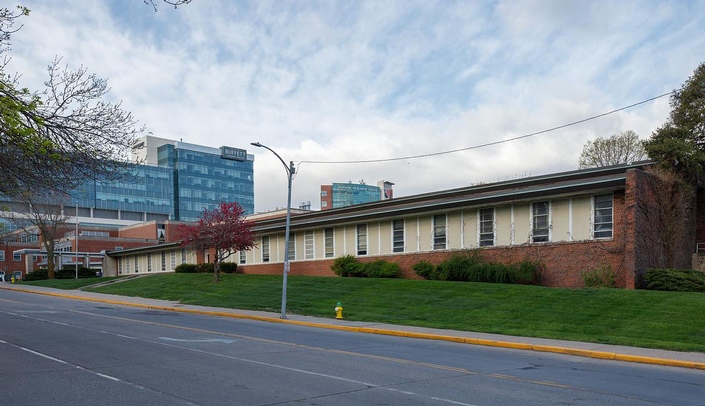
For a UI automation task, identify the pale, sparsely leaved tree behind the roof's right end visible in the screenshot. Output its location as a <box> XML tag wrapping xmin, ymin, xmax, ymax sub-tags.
<box><xmin>578</xmin><ymin>130</ymin><xmax>646</xmax><ymax>169</ymax></box>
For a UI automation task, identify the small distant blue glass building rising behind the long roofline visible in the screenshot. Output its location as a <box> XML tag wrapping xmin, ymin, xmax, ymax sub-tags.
<box><xmin>321</xmin><ymin>180</ymin><xmax>394</xmax><ymax>210</ymax></box>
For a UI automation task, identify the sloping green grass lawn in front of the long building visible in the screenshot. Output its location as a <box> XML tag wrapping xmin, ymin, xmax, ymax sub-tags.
<box><xmin>22</xmin><ymin>274</ymin><xmax>705</xmax><ymax>352</ymax></box>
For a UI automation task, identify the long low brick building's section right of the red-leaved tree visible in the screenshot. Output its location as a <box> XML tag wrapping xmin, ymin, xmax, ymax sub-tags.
<box><xmin>235</xmin><ymin>162</ymin><xmax>705</xmax><ymax>288</ymax></box>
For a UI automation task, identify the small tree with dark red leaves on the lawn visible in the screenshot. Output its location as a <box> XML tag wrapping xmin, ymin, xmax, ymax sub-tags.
<box><xmin>177</xmin><ymin>202</ymin><xmax>255</xmax><ymax>282</ymax></box>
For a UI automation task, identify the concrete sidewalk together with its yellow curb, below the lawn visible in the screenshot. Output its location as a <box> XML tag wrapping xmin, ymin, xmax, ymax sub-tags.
<box><xmin>0</xmin><ymin>282</ymin><xmax>705</xmax><ymax>370</ymax></box>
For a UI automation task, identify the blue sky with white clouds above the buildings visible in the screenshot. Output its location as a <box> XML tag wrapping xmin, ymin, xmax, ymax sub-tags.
<box><xmin>7</xmin><ymin>0</ymin><xmax>705</xmax><ymax>211</ymax></box>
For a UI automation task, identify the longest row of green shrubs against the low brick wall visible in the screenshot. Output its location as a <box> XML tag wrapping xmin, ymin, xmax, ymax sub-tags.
<box><xmin>413</xmin><ymin>251</ymin><xmax>543</xmax><ymax>285</ymax></box>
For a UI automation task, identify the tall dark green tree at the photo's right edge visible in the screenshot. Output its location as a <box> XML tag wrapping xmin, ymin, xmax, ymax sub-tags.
<box><xmin>645</xmin><ymin>63</ymin><xmax>705</xmax><ymax>185</ymax></box>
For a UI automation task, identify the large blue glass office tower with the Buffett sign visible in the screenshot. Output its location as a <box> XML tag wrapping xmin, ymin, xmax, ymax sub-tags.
<box><xmin>0</xmin><ymin>136</ymin><xmax>255</xmax><ymax>227</ymax></box>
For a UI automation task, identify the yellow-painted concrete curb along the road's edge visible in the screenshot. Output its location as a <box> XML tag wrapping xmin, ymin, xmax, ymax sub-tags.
<box><xmin>5</xmin><ymin>288</ymin><xmax>705</xmax><ymax>370</ymax></box>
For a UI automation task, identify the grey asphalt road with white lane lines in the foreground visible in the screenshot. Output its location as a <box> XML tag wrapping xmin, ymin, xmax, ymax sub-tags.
<box><xmin>0</xmin><ymin>290</ymin><xmax>705</xmax><ymax>406</ymax></box>
